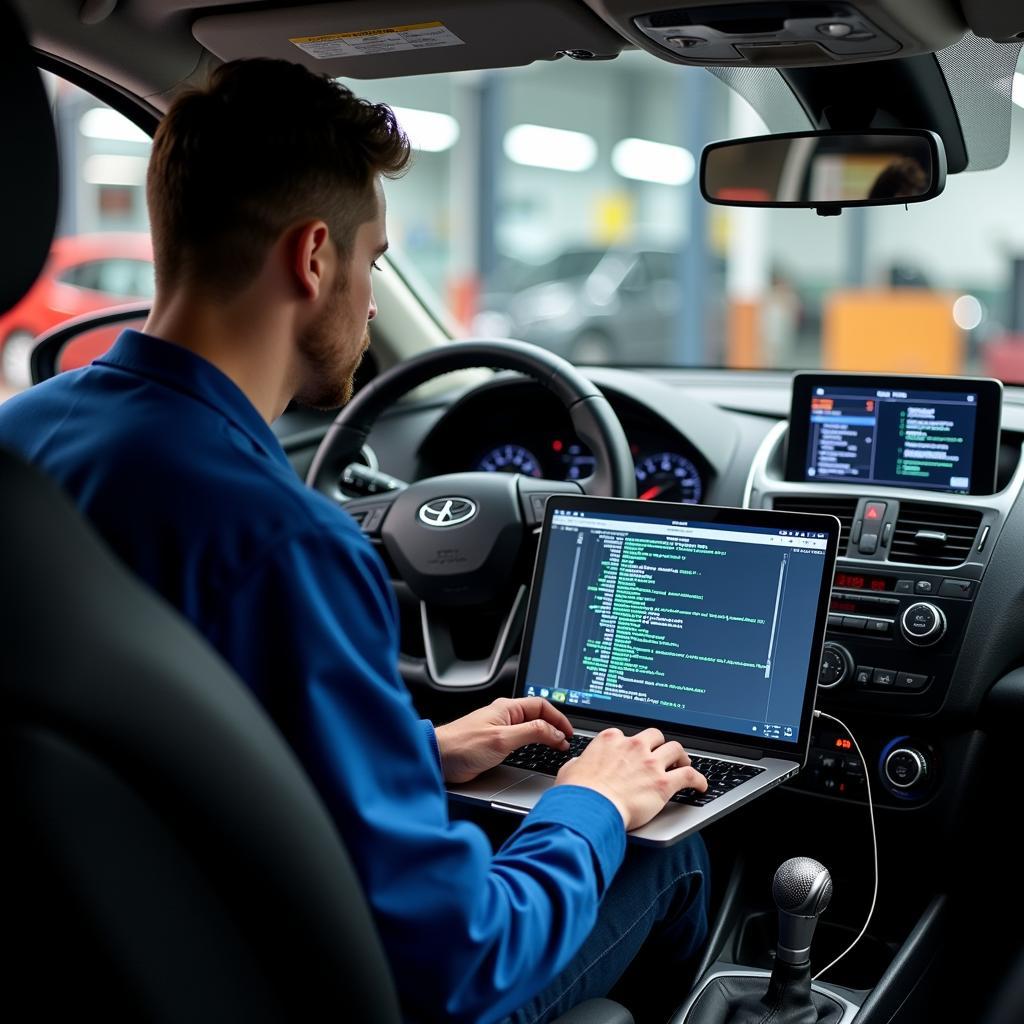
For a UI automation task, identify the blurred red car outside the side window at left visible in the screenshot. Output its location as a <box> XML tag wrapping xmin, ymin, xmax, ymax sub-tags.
<box><xmin>0</xmin><ymin>232</ymin><xmax>154</xmax><ymax>387</ymax></box>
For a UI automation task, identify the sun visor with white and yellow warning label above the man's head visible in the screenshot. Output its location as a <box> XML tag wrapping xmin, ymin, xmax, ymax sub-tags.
<box><xmin>193</xmin><ymin>0</ymin><xmax>625</xmax><ymax>78</ymax></box>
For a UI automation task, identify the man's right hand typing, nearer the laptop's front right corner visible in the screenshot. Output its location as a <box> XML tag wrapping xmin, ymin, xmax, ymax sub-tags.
<box><xmin>555</xmin><ymin>729</ymin><xmax>708</xmax><ymax>831</ymax></box>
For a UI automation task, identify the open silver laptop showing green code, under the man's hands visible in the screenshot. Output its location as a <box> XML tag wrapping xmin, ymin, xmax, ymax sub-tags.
<box><xmin>449</xmin><ymin>496</ymin><xmax>840</xmax><ymax>846</ymax></box>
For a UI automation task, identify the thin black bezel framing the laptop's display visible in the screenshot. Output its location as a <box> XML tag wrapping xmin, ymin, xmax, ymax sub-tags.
<box><xmin>514</xmin><ymin>495</ymin><xmax>840</xmax><ymax>760</ymax></box>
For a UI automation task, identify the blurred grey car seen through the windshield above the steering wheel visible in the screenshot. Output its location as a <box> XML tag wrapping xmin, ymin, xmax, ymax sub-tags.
<box><xmin>472</xmin><ymin>248</ymin><xmax>680</xmax><ymax>365</ymax></box>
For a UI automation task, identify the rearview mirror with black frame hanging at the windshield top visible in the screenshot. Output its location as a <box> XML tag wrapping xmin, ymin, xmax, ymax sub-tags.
<box><xmin>700</xmin><ymin>129</ymin><xmax>946</xmax><ymax>216</ymax></box>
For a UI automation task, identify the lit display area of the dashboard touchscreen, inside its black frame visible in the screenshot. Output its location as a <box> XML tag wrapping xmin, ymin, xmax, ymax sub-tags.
<box><xmin>807</xmin><ymin>387</ymin><xmax>978</xmax><ymax>495</ymax></box>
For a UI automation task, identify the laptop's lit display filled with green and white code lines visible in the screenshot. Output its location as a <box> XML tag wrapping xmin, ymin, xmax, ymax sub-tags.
<box><xmin>524</xmin><ymin>511</ymin><xmax>827</xmax><ymax>742</ymax></box>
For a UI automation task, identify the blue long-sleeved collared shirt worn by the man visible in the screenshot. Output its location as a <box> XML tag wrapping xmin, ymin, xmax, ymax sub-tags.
<box><xmin>0</xmin><ymin>331</ymin><xmax>625</xmax><ymax>1021</ymax></box>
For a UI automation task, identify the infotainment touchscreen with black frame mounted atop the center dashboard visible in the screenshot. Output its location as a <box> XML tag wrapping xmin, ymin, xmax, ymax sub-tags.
<box><xmin>786</xmin><ymin>374</ymin><xmax>1002</xmax><ymax>495</ymax></box>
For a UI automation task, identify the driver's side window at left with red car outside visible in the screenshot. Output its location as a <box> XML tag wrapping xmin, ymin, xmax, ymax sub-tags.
<box><xmin>0</xmin><ymin>73</ymin><xmax>154</xmax><ymax>400</ymax></box>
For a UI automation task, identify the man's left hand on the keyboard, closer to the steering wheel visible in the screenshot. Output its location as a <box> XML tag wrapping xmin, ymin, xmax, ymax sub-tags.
<box><xmin>434</xmin><ymin>697</ymin><xmax>572</xmax><ymax>782</ymax></box>
